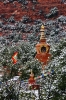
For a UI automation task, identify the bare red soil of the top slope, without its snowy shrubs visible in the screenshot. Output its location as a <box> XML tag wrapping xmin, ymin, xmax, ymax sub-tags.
<box><xmin>0</xmin><ymin>0</ymin><xmax>66</xmax><ymax>20</ymax></box>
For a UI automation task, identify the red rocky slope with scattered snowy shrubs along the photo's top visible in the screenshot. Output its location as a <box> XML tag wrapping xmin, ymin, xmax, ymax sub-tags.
<box><xmin>0</xmin><ymin>0</ymin><xmax>66</xmax><ymax>20</ymax></box>
